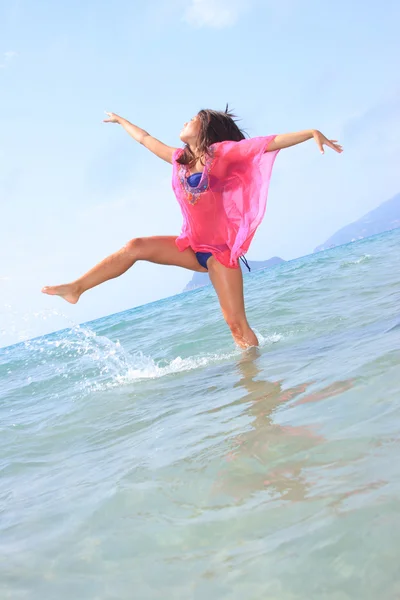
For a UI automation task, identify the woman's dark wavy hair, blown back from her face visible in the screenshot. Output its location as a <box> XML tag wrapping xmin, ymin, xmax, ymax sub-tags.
<box><xmin>177</xmin><ymin>105</ymin><xmax>245</xmax><ymax>166</ymax></box>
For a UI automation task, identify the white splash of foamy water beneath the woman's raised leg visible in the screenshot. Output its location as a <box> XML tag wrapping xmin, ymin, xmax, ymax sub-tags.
<box><xmin>3</xmin><ymin>311</ymin><xmax>283</xmax><ymax>396</ymax></box>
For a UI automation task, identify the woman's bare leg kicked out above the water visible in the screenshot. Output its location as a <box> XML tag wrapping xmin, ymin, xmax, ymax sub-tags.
<box><xmin>42</xmin><ymin>236</ymin><xmax>206</xmax><ymax>304</ymax></box>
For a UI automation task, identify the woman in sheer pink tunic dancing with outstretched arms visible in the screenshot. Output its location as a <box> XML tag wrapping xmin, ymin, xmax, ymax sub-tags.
<box><xmin>42</xmin><ymin>107</ymin><xmax>342</xmax><ymax>348</ymax></box>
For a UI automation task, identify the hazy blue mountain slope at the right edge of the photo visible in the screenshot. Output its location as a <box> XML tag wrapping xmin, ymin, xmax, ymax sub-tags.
<box><xmin>314</xmin><ymin>194</ymin><xmax>400</xmax><ymax>252</ymax></box>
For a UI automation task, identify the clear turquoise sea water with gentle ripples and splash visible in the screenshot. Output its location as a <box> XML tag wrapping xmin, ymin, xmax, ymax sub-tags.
<box><xmin>0</xmin><ymin>230</ymin><xmax>400</xmax><ymax>600</ymax></box>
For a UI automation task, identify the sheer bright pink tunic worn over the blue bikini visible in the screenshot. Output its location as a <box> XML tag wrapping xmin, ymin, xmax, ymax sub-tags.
<box><xmin>172</xmin><ymin>135</ymin><xmax>278</xmax><ymax>268</ymax></box>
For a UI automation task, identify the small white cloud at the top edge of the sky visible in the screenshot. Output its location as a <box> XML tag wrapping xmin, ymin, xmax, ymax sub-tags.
<box><xmin>184</xmin><ymin>0</ymin><xmax>250</xmax><ymax>29</ymax></box>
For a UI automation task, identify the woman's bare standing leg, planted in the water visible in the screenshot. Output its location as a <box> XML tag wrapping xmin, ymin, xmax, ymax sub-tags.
<box><xmin>207</xmin><ymin>256</ymin><xmax>258</xmax><ymax>348</ymax></box>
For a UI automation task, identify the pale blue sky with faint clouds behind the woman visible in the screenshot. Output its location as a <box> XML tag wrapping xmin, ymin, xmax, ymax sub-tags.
<box><xmin>0</xmin><ymin>0</ymin><xmax>400</xmax><ymax>345</ymax></box>
